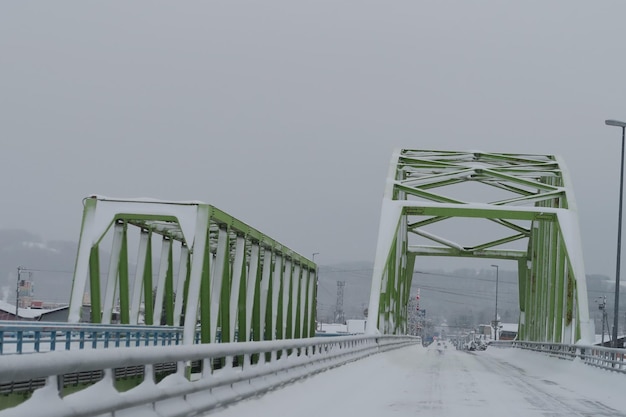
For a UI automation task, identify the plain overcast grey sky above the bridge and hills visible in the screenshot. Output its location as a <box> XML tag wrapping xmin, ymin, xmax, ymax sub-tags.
<box><xmin>0</xmin><ymin>0</ymin><xmax>626</xmax><ymax>276</ymax></box>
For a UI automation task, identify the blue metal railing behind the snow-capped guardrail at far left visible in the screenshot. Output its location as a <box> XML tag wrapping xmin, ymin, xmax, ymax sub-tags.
<box><xmin>0</xmin><ymin>321</ymin><xmax>188</xmax><ymax>355</ymax></box>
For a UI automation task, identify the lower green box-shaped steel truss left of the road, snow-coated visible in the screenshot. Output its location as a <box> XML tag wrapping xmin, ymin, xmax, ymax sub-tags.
<box><xmin>69</xmin><ymin>196</ymin><xmax>317</xmax><ymax>344</ymax></box>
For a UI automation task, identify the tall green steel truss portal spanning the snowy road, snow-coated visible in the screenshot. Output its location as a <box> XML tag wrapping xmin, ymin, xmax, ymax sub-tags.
<box><xmin>368</xmin><ymin>149</ymin><xmax>593</xmax><ymax>343</ymax></box>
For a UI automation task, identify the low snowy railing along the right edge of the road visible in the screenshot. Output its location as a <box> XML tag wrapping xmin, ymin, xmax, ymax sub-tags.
<box><xmin>492</xmin><ymin>341</ymin><xmax>626</xmax><ymax>373</ymax></box>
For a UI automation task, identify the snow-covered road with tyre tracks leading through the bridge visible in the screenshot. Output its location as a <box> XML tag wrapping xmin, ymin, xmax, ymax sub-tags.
<box><xmin>210</xmin><ymin>346</ymin><xmax>626</xmax><ymax>417</ymax></box>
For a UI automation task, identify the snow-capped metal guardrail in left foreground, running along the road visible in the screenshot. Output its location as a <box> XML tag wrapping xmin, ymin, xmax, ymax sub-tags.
<box><xmin>0</xmin><ymin>335</ymin><xmax>419</xmax><ymax>417</ymax></box>
